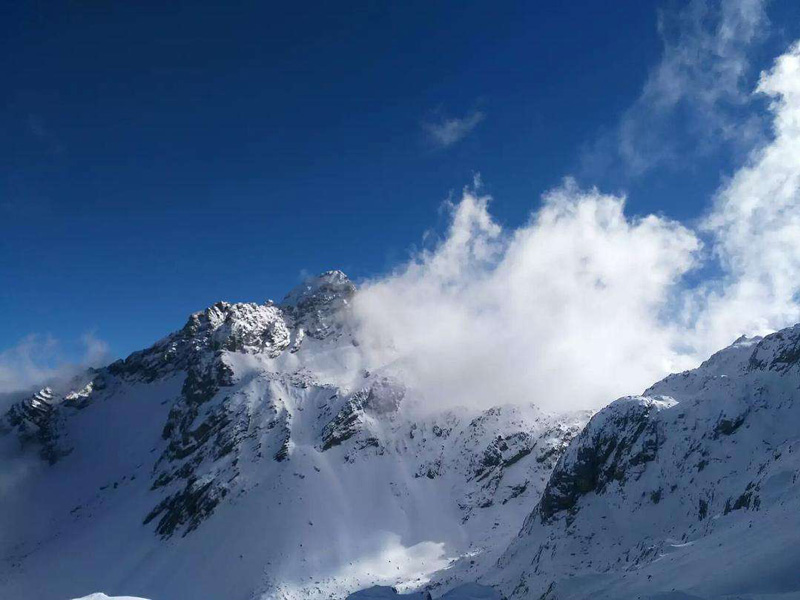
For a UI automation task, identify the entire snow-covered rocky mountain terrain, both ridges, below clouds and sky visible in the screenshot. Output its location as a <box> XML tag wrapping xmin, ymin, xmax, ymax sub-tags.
<box><xmin>0</xmin><ymin>271</ymin><xmax>800</xmax><ymax>600</ymax></box>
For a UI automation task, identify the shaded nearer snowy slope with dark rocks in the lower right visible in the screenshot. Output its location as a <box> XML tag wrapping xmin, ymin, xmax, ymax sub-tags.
<box><xmin>485</xmin><ymin>325</ymin><xmax>800</xmax><ymax>600</ymax></box>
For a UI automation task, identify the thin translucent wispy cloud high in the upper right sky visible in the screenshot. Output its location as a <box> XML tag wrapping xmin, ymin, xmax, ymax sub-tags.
<box><xmin>583</xmin><ymin>0</ymin><xmax>769</xmax><ymax>176</ymax></box>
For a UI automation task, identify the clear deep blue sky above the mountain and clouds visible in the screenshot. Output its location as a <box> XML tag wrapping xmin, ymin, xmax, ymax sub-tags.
<box><xmin>0</xmin><ymin>0</ymin><xmax>798</xmax><ymax>356</ymax></box>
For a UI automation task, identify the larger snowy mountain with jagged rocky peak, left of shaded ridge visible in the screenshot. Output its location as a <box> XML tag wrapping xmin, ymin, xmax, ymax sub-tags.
<box><xmin>0</xmin><ymin>271</ymin><xmax>589</xmax><ymax>600</ymax></box>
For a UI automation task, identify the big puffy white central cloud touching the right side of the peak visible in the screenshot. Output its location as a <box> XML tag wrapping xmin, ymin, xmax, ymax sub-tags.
<box><xmin>354</xmin><ymin>182</ymin><xmax>699</xmax><ymax>408</ymax></box>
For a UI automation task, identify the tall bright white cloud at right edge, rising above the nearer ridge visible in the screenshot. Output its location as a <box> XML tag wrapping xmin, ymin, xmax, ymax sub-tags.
<box><xmin>698</xmin><ymin>43</ymin><xmax>800</xmax><ymax>352</ymax></box>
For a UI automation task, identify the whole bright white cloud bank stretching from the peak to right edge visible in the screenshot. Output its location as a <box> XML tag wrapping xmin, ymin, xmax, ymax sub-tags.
<box><xmin>354</xmin><ymin>45</ymin><xmax>800</xmax><ymax>409</ymax></box>
